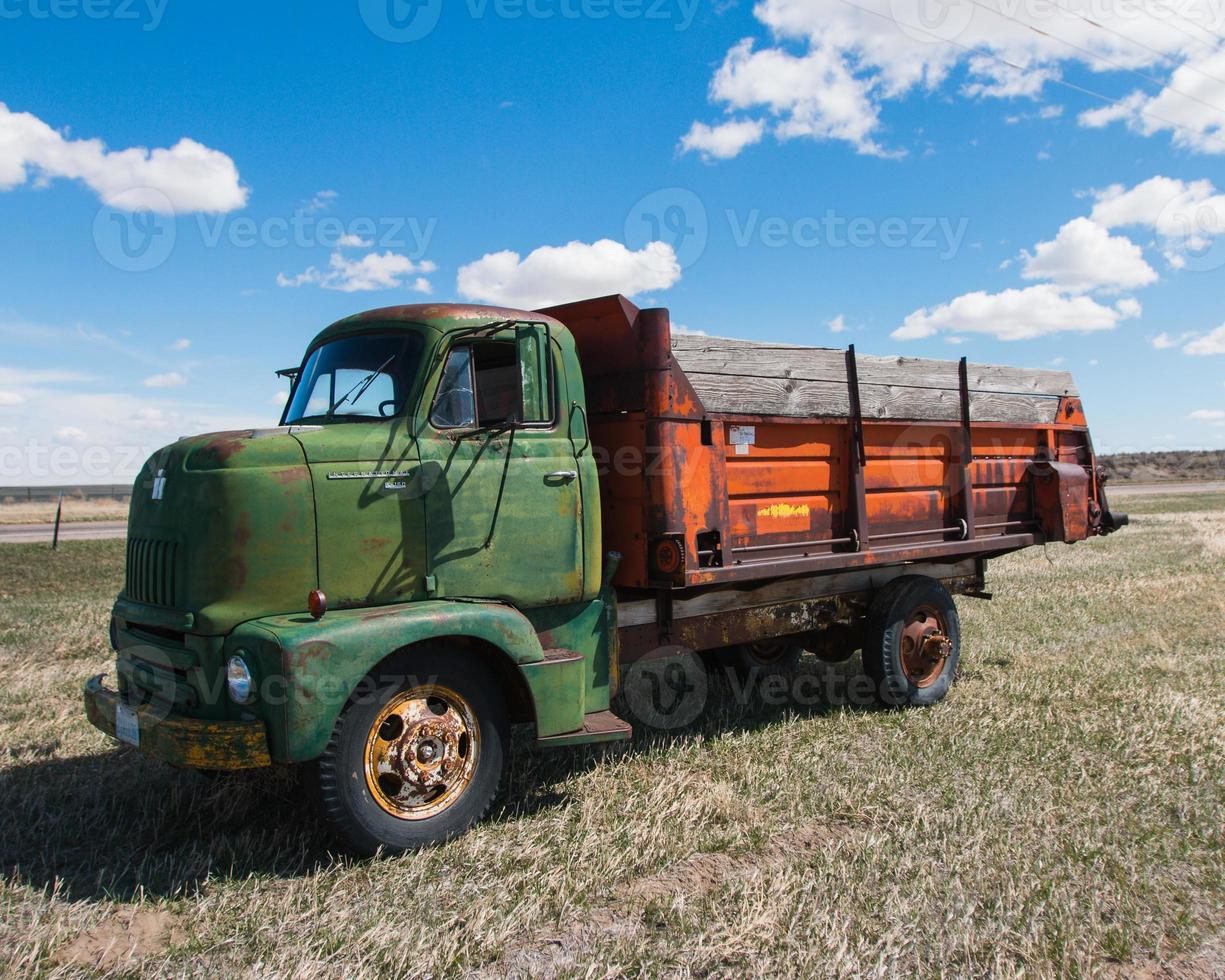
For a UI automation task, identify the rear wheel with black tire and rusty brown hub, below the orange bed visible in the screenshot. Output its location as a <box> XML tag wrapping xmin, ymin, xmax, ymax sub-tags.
<box><xmin>864</xmin><ymin>576</ymin><xmax>962</xmax><ymax>707</ymax></box>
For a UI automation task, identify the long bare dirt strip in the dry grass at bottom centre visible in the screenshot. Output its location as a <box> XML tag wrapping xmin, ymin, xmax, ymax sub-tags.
<box><xmin>472</xmin><ymin>823</ymin><xmax>853</xmax><ymax>980</ymax></box>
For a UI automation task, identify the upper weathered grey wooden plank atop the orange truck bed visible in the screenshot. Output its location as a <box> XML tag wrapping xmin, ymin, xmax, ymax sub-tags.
<box><xmin>673</xmin><ymin>334</ymin><xmax>1077</xmax><ymax>396</ymax></box>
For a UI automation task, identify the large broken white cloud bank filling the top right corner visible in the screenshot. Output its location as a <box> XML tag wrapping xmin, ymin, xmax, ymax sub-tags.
<box><xmin>681</xmin><ymin>0</ymin><xmax>1225</xmax><ymax>157</ymax></box>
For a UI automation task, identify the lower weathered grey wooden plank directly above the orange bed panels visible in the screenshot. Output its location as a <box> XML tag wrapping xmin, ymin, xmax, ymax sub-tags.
<box><xmin>687</xmin><ymin>372</ymin><xmax>1058</xmax><ymax>424</ymax></box>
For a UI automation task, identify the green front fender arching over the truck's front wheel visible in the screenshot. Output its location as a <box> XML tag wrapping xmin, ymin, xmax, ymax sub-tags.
<box><xmin>235</xmin><ymin>599</ymin><xmax>551</xmax><ymax>762</ymax></box>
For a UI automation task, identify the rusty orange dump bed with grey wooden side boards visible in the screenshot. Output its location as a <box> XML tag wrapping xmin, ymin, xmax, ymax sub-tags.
<box><xmin>545</xmin><ymin>296</ymin><xmax>1114</xmax><ymax>588</ymax></box>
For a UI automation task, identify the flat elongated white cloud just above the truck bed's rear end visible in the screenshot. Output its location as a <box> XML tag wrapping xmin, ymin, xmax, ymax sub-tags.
<box><xmin>891</xmin><ymin>283</ymin><xmax>1140</xmax><ymax>341</ymax></box>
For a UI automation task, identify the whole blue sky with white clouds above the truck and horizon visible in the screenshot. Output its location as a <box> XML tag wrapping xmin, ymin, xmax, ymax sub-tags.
<box><xmin>0</xmin><ymin>0</ymin><xmax>1225</xmax><ymax>486</ymax></box>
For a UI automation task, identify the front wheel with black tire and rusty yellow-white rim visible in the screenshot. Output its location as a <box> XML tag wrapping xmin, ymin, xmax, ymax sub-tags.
<box><xmin>314</xmin><ymin>647</ymin><xmax>508</xmax><ymax>856</ymax></box>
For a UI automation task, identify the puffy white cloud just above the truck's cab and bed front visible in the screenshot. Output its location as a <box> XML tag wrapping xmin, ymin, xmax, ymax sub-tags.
<box><xmin>457</xmin><ymin>239</ymin><xmax>681</xmax><ymax>309</ymax></box>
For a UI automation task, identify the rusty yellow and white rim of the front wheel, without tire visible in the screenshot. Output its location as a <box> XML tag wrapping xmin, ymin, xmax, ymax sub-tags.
<box><xmin>365</xmin><ymin>686</ymin><xmax>480</xmax><ymax>820</ymax></box>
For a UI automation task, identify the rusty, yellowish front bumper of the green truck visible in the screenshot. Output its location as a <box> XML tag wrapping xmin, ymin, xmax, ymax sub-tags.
<box><xmin>85</xmin><ymin>674</ymin><xmax>272</xmax><ymax>769</ymax></box>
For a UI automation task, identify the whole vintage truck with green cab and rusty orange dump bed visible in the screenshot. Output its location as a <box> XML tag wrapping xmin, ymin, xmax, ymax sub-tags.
<box><xmin>85</xmin><ymin>296</ymin><xmax>1126</xmax><ymax>854</ymax></box>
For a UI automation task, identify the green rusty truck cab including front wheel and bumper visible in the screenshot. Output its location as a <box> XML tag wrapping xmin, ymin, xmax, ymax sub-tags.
<box><xmin>86</xmin><ymin>305</ymin><xmax>628</xmax><ymax>853</ymax></box>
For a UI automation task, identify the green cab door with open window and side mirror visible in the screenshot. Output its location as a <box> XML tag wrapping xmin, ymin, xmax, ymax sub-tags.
<box><xmin>419</xmin><ymin>325</ymin><xmax>584</xmax><ymax>609</ymax></box>
